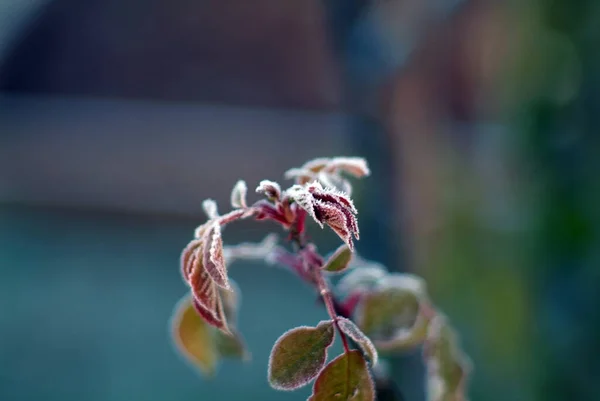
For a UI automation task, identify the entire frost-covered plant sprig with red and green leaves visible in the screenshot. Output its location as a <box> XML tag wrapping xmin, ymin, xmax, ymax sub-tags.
<box><xmin>172</xmin><ymin>157</ymin><xmax>470</xmax><ymax>401</ymax></box>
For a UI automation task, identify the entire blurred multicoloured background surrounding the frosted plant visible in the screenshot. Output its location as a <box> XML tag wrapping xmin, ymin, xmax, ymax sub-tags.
<box><xmin>0</xmin><ymin>0</ymin><xmax>600</xmax><ymax>401</ymax></box>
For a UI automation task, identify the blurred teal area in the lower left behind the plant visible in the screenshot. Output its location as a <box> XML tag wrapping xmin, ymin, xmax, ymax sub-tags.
<box><xmin>0</xmin><ymin>206</ymin><xmax>339</xmax><ymax>401</ymax></box>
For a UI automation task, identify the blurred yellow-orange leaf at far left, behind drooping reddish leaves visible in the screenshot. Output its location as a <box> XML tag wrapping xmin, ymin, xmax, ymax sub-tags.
<box><xmin>171</xmin><ymin>295</ymin><xmax>219</xmax><ymax>376</ymax></box>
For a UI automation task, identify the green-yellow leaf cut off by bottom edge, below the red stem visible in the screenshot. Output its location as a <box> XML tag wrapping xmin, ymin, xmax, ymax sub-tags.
<box><xmin>308</xmin><ymin>350</ymin><xmax>375</xmax><ymax>401</ymax></box>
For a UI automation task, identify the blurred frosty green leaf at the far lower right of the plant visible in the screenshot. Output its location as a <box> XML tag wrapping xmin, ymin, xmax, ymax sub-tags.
<box><xmin>423</xmin><ymin>314</ymin><xmax>471</xmax><ymax>401</ymax></box>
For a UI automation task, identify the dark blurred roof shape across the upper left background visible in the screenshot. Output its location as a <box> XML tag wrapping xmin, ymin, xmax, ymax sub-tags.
<box><xmin>0</xmin><ymin>0</ymin><xmax>339</xmax><ymax>109</ymax></box>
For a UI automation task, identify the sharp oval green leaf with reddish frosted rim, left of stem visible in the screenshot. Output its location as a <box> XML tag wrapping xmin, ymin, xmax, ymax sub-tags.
<box><xmin>268</xmin><ymin>320</ymin><xmax>335</xmax><ymax>390</ymax></box>
